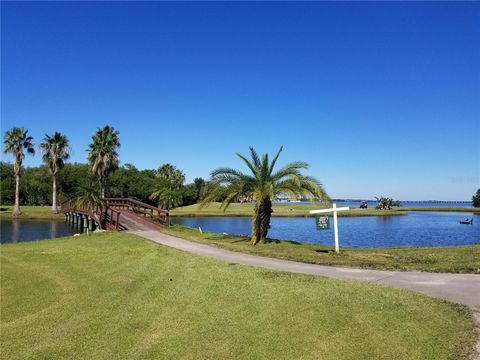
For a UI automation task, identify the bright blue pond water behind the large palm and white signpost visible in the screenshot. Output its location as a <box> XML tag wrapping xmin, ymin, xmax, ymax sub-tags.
<box><xmin>171</xmin><ymin>212</ymin><xmax>480</xmax><ymax>247</ymax></box>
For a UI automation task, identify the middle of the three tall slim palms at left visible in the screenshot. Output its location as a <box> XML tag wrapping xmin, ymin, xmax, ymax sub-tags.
<box><xmin>40</xmin><ymin>132</ymin><xmax>70</xmax><ymax>214</ymax></box>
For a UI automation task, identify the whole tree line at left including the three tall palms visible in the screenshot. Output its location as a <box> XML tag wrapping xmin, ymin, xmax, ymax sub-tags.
<box><xmin>0</xmin><ymin>125</ymin><xmax>234</xmax><ymax>216</ymax></box>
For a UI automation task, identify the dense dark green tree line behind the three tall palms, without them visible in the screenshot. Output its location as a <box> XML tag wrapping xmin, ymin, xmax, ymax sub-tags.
<box><xmin>0</xmin><ymin>161</ymin><xmax>217</xmax><ymax>209</ymax></box>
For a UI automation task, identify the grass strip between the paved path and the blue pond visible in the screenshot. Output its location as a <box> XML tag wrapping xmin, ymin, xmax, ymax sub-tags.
<box><xmin>164</xmin><ymin>225</ymin><xmax>480</xmax><ymax>274</ymax></box>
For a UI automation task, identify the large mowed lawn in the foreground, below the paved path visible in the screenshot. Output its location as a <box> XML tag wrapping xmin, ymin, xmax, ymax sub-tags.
<box><xmin>0</xmin><ymin>233</ymin><xmax>475</xmax><ymax>360</ymax></box>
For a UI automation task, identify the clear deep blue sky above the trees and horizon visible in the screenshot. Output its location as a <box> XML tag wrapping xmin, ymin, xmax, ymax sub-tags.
<box><xmin>1</xmin><ymin>2</ymin><xmax>480</xmax><ymax>200</ymax></box>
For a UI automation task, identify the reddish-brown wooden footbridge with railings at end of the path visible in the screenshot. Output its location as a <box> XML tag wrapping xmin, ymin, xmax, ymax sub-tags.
<box><xmin>62</xmin><ymin>198</ymin><xmax>170</xmax><ymax>231</ymax></box>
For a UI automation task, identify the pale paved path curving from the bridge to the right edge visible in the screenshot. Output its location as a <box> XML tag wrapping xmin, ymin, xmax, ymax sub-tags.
<box><xmin>129</xmin><ymin>230</ymin><xmax>480</xmax><ymax>360</ymax></box>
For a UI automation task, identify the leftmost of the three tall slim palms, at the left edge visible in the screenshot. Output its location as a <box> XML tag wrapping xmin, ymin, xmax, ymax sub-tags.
<box><xmin>3</xmin><ymin>127</ymin><xmax>35</xmax><ymax>216</ymax></box>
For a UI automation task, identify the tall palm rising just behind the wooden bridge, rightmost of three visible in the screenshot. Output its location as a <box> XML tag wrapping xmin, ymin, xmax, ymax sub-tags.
<box><xmin>87</xmin><ymin>125</ymin><xmax>120</xmax><ymax>198</ymax></box>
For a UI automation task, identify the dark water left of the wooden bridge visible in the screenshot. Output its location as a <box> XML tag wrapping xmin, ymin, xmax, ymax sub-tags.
<box><xmin>0</xmin><ymin>219</ymin><xmax>78</xmax><ymax>244</ymax></box>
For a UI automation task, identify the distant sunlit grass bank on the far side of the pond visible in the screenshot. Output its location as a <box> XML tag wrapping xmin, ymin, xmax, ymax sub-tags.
<box><xmin>170</xmin><ymin>203</ymin><xmax>406</xmax><ymax>217</ymax></box>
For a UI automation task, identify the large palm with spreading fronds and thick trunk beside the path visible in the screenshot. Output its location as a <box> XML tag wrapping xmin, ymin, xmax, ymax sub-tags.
<box><xmin>202</xmin><ymin>146</ymin><xmax>330</xmax><ymax>245</ymax></box>
